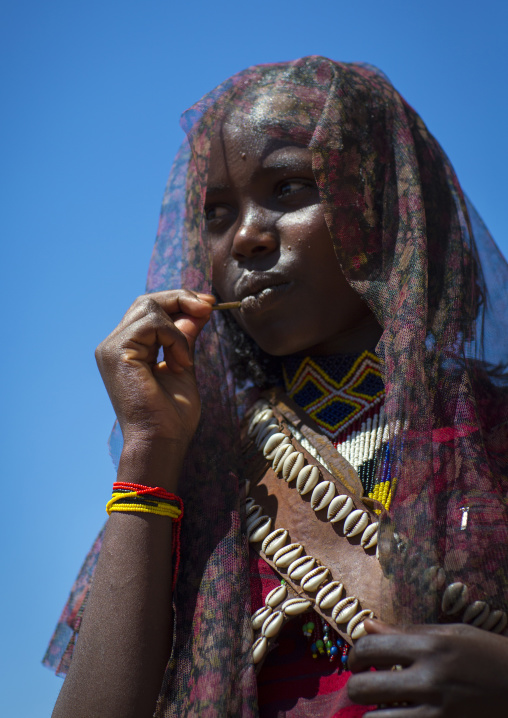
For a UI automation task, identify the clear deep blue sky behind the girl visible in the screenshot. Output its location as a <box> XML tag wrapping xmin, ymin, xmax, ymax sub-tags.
<box><xmin>0</xmin><ymin>0</ymin><xmax>508</xmax><ymax>718</ymax></box>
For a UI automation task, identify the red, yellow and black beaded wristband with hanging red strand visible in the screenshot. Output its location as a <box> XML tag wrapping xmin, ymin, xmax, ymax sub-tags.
<box><xmin>106</xmin><ymin>481</ymin><xmax>183</xmax><ymax>590</ymax></box>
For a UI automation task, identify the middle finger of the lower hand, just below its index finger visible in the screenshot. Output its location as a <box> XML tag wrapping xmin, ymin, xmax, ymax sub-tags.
<box><xmin>347</xmin><ymin>668</ymin><xmax>428</xmax><ymax>705</ymax></box>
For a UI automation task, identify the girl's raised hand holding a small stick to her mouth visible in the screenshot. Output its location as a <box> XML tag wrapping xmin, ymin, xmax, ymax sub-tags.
<box><xmin>96</xmin><ymin>289</ymin><xmax>215</xmax><ymax>462</ymax></box>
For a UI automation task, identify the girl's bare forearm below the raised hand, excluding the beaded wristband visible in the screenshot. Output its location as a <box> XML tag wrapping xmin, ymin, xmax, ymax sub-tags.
<box><xmin>53</xmin><ymin>446</ymin><xmax>184</xmax><ymax>718</ymax></box>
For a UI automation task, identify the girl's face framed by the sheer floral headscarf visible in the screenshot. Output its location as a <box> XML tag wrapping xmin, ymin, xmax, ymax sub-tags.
<box><xmin>205</xmin><ymin>123</ymin><xmax>381</xmax><ymax>356</ymax></box>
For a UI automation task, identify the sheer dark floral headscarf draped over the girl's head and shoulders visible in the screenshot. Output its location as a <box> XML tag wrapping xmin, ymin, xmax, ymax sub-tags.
<box><xmin>43</xmin><ymin>57</ymin><xmax>508</xmax><ymax>718</ymax></box>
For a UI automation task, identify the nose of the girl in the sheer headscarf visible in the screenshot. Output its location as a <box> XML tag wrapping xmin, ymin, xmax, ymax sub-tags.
<box><xmin>231</xmin><ymin>207</ymin><xmax>279</xmax><ymax>261</ymax></box>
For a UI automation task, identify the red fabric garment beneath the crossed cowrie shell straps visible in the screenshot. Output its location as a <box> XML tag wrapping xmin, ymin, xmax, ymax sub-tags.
<box><xmin>250</xmin><ymin>549</ymin><xmax>369</xmax><ymax>718</ymax></box>
